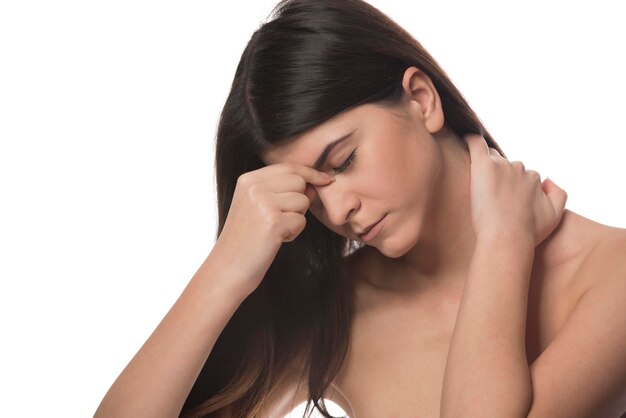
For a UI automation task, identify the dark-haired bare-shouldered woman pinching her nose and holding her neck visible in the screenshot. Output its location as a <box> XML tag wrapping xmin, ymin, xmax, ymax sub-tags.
<box><xmin>96</xmin><ymin>0</ymin><xmax>626</xmax><ymax>418</ymax></box>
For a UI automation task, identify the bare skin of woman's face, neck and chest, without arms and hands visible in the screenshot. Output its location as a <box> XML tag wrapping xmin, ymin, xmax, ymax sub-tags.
<box><xmin>256</xmin><ymin>68</ymin><xmax>626</xmax><ymax>418</ymax></box>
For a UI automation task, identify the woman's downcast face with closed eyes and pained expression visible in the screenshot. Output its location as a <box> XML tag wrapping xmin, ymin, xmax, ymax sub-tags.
<box><xmin>262</xmin><ymin>67</ymin><xmax>443</xmax><ymax>258</ymax></box>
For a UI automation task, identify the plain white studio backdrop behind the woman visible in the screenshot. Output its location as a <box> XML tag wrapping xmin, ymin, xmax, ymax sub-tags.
<box><xmin>0</xmin><ymin>0</ymin><xmax>626</xmax><ymax>417</ymax></box>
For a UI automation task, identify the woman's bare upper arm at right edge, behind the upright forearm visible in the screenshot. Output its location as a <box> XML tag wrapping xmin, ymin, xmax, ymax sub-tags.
<box><xmin>528</xmin><ymin>227</ymin><xmax>626</xmax><ymax>417</ymax></box>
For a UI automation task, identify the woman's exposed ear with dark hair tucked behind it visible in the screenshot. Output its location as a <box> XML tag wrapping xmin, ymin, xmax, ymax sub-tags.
<box><xmin>402</xmin><ymin>67</ymin><xmax>445</xmax><ymax>134</ymax></box>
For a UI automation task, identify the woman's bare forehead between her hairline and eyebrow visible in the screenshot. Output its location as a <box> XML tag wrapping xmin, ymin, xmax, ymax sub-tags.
<box><xmin>261</xmin><ymin>104</ymin><xmax>381</xmax><ymax>167</ymax></box>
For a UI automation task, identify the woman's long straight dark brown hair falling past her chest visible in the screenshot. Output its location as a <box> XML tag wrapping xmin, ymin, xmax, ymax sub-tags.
<box><xmin>181</xmin><ymin>0</ymin><xmax>504</xmax><ymax>418</ymax></box>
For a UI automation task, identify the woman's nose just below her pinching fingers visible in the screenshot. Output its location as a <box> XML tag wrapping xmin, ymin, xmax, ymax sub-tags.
<box><xmin>311</xmin><ymin>179</ymin><xmax>361</xmax><ymax>227</ymax></box>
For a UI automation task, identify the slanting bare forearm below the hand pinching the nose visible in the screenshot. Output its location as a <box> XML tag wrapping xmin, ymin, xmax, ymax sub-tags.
<box><xmin>94</xmin><ymin>256</ymin><xmax>244</xmax><ymax>418</ymax></box>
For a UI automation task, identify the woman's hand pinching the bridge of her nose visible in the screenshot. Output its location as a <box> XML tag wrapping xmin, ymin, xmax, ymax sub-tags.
<box><xmin>210</xmin><ymin>163</ymin><xmax>332</xmax><ymax>296</ymax></box>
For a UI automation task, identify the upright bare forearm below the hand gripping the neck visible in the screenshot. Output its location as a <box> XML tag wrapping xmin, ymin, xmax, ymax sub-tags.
<box><xmin>441</xmin><ymin>233</ymin><xmax>534</xmax><ymax>418</ymax></box>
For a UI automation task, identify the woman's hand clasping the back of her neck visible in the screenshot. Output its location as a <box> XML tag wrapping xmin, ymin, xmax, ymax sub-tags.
<box><xmin>464</xmin><ymin>134</ymin><xmax>567</xmax><ymax>246</ymax></box>
